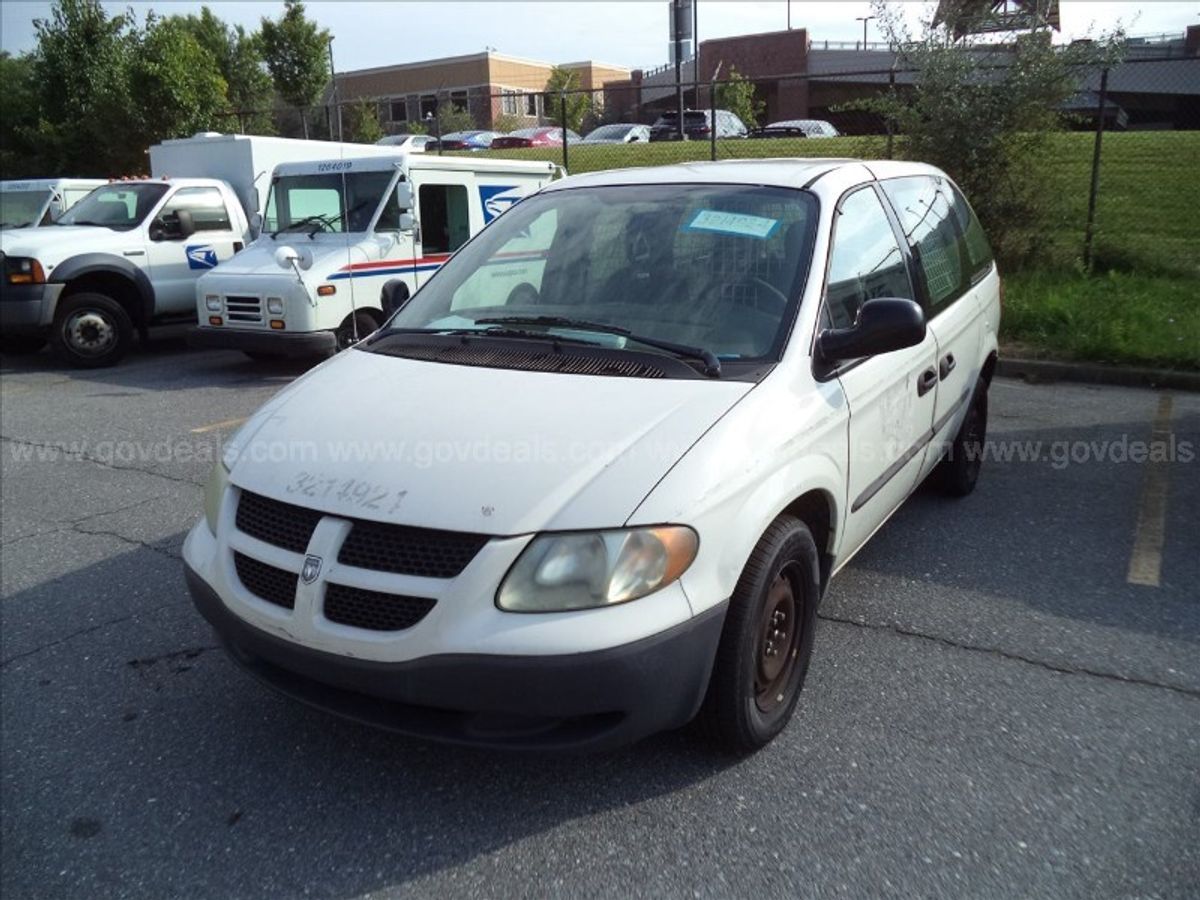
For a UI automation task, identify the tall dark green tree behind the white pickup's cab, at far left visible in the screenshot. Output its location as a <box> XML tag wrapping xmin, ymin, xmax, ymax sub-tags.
<box><xmin>30</xmin><ymin>0</ymin><xmax>137</xmax><ymax>175</ymax></box>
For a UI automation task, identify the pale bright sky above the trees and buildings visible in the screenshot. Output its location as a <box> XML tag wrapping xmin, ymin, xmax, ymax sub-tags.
<box><xmin>0</xmin><ymin>0</ymin><xmax>1200</xmax><ymax>71</ymax></box>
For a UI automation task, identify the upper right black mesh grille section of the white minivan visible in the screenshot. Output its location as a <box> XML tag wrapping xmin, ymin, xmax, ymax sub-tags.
<box><xmin>337</xmin><ymin>521</ymin><xmax>488</xmax><ymax>578</ymax></box>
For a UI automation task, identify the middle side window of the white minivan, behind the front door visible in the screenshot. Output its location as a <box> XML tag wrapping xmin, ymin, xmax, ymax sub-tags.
<box><xmin>882</xmin><ymin>175</ymin><xmax>968</xmax><ymax>317</ymax></box>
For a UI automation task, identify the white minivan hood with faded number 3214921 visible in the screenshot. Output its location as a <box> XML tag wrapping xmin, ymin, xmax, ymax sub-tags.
<box><xmin>226</xmin><ymin>350</ymin><xmax>754</xmax><ymax>535</ymax></box>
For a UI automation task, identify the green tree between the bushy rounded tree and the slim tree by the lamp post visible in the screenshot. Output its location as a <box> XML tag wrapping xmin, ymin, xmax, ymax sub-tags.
<box><xmin>182</xmin><ymin>6</ymin><xmax>275</xmax><ymax>134</ymax></box>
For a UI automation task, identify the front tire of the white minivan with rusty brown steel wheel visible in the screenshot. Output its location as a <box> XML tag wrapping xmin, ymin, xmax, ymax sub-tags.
<box><xmin>700</xmin><ymin>516</ymin><xmax>821</xmax><ymax>754</ymax></box>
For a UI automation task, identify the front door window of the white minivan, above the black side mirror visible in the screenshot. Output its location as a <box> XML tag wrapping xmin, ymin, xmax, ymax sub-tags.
<box><xmin>826</xmin><ymin>187</ymin><xmax>912</xmax><ymax>328</ymax></box>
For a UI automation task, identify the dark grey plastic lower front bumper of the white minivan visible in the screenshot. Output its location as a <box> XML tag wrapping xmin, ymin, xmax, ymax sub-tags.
<box><xmin>184</xmin><ymin>563</ymin><xmax>726</xmax><ymax>751</ymax></box>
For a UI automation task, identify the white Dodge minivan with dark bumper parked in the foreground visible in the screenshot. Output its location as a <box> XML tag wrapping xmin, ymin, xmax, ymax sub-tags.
<box><xmin>184</xmin><ymin>160</ymin><xmax>1000</xmax><ymax>751</ymax></box>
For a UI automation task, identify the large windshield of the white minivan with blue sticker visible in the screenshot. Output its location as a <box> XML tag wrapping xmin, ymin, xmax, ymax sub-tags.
<box><xmin>385</xmin><ymin>184</ymin><xmax>817</xmax><ymax>361</ymax></box>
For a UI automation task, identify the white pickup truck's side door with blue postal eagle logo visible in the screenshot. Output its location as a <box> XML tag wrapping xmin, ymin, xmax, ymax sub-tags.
<box><xmin>145</xmin><ymin>187</ymin><xmax>242</xmax><ymax>314</ymax></box>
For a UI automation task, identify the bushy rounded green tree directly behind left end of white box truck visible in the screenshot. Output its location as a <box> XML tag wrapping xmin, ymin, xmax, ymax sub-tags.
<box><xmin>130</xmin><ymin>17</ymin><xmax>227</xmax><ymax>148</ymax></box>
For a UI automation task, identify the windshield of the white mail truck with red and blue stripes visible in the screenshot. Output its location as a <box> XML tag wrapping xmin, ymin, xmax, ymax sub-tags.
<box><xmin>263</xmin><ymin>170</ymin><xmax>396</xmax><ymax>234</ymax></box>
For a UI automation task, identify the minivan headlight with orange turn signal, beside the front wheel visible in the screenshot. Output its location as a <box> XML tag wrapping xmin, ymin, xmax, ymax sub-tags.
<box><xmin>496</xmin><ymin>526</ymin><xmax>700</xmax><ymax>612</ymax></box>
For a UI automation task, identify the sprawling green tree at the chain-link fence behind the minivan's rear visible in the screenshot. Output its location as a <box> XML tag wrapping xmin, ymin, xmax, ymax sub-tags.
<box><xmin>848</xmin><ymin>2</ymin><xmax>1123</xmax><ymax>268</ymax></box>
